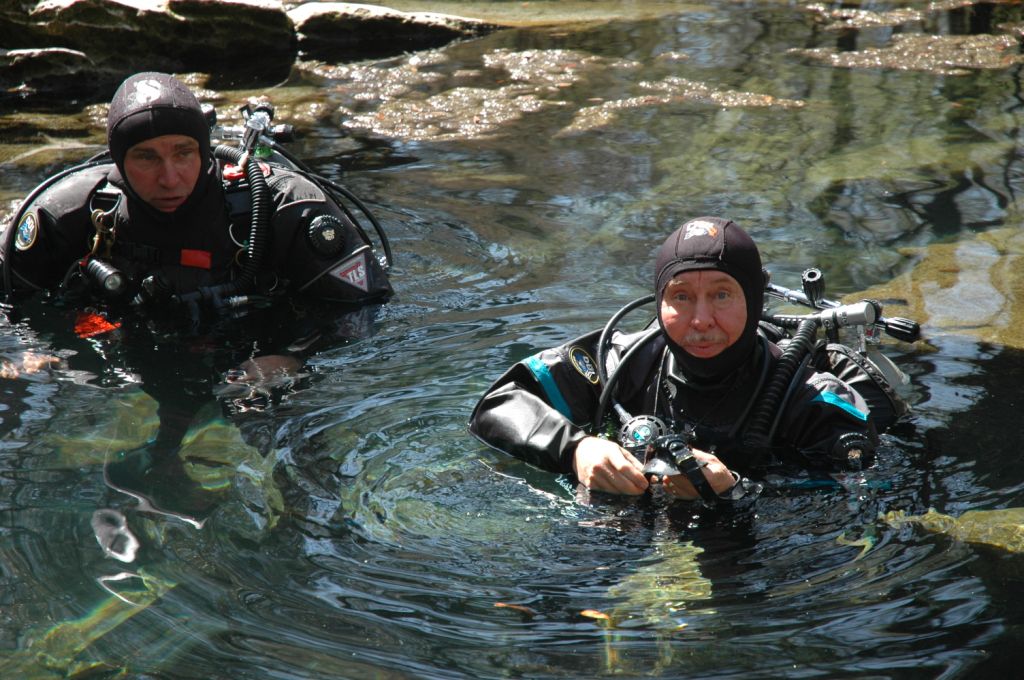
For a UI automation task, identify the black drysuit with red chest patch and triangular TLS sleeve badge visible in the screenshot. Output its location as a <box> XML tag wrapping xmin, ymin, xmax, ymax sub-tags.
<box><xmin>3</xmin><ymin>156</ymin><xmax>391</xmax><ymax>304</ymax></box>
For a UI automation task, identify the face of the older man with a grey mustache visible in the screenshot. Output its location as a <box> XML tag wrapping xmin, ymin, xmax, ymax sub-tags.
<box><xmin>659</xmin><ymin>269</ymin><xmax>746</xmax><ymax>358</ymax></box>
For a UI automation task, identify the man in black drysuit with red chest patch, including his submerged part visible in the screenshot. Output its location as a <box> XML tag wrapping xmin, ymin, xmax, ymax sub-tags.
<box><xmin>0</xmin><ymin>73</ymin><xmax>392</xmax><ymax>520</ymax></box>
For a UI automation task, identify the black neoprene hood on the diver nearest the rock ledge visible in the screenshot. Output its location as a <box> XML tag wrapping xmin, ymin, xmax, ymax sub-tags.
<box><xmin>106</xmin><ymin>72</ymin><xmax>210</xmax><ymax>176</ymax></box>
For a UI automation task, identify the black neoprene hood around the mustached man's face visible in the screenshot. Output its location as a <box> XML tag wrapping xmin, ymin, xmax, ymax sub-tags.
<box><xmin>654</xmin><ymin>217</ymin><xmax>765</xmax><ymax>381</ymax></box>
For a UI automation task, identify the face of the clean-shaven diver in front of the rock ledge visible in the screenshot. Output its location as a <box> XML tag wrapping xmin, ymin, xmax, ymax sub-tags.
<box><xmin>124</xmin><ymin>134</ymin><xmax>203</xmax><ymax>213</ymax></box>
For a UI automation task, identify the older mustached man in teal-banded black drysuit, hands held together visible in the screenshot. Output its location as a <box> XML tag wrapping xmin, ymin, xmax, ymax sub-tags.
<box><xmin>470</xmin><ymin>217</ymin><xmax>888</xmax><ymax>500</ymax></box>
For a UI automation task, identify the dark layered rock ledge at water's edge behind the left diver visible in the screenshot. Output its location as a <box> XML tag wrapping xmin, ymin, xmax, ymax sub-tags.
<box><xmin>0</xmin><ymin>0</ymin><xmax>498</xmax><ymax>100</ymax></box>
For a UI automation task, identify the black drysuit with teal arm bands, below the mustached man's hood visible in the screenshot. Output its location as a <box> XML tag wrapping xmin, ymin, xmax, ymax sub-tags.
<box><xmin>470</xmin><ymin>325</ymin><xmax>898</xmax><ymax>474</ymax></box>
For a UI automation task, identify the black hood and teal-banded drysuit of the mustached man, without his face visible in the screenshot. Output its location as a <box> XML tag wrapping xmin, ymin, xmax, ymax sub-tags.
<box><xmin>470</xmin><ymin>217</ymin><xmax>905</xmax><ymax>500</ymax></box>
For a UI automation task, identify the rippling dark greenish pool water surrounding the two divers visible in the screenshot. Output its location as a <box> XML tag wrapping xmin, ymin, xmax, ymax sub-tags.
<box><xmin>0</xmin><ymin>2</ymin><xmax>1024</xmax><ymax>679</ymax></box>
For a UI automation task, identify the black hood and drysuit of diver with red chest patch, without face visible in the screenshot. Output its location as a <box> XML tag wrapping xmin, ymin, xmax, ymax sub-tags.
<box><xmin>3</xmin><ymin>73</ymin><xmax>391</xmax><ymax>305</ymax></box>
